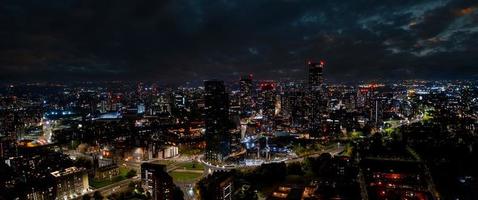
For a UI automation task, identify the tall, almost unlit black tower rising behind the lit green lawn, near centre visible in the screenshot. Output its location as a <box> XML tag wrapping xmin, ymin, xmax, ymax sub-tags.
<box><xmin>204</xmin><ymin>80</ymin><xmax>231</xmax><ymax>162</ymax></box>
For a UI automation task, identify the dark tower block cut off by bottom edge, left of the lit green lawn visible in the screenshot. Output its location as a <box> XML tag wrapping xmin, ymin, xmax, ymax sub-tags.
<box><xmin>141</xmin><ymin>163</ymin><xmax>175</xmax><ymax>200</ymax></box>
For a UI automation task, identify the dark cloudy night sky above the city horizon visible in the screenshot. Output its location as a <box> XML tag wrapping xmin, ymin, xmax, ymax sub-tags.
<box><xmin>0</xmin><ymin>0</ymin><xmax>478</xmax><ymax>82</ymax></box>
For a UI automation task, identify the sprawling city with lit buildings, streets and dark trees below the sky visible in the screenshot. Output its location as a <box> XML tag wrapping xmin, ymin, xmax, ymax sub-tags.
<box><xmin>0</xmin><ymin>69</ymin><xmax>478</xmax><ymax>200</ymax></box>
